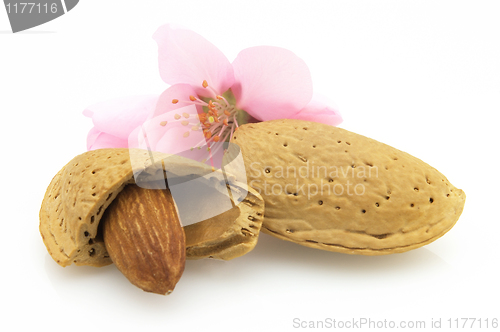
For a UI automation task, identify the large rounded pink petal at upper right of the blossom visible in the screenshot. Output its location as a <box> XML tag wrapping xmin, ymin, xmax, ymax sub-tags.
<box><xmin>231</xmin><ymin>46</ymin><xmax>313</xmax><ymax>121</ymax></box>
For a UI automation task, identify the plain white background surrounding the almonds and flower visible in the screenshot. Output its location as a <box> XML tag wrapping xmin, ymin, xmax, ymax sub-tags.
<box><xmin>0</xmin><ymin>0</ymin><xmax>500</xmax><ymax>331</ymax></box>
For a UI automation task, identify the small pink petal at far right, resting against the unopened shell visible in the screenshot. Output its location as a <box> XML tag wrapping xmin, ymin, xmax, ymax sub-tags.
<box><xmin>288</xmin><ymin>94</ymin><xmax>342</xmax><ymax>126</ymax></box>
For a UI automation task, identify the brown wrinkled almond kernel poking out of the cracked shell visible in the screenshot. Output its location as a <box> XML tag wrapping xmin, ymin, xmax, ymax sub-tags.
<box><xmin>101</xmin><ymin>184</ymin><xmax>186</xmax><ymax>294</ymax></box>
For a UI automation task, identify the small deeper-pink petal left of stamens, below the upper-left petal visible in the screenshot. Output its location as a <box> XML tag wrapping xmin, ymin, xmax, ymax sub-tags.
<box><xmin>148</xmin><ymin>84</ymin><xmax>202</xmax><ymax>119</ymax></box>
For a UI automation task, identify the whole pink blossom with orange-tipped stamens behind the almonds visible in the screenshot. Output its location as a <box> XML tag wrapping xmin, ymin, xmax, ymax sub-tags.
<box><xmin>86</xmin><ymin>25</ymin><xmax>342</xmax><ymax>154</ymax></box>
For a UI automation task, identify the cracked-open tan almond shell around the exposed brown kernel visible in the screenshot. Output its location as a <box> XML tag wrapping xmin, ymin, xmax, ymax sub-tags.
<box><xmin>39</xmin><ymin>149</ymin><xmax>264</xmax><ymax>266</ymax></box>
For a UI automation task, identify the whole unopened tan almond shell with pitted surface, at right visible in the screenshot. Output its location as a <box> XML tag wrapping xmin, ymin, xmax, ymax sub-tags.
<box><xmin>233</xmin><ymin>120</ymin><xmax>465</xmax><ymax>255</ymax></box>
